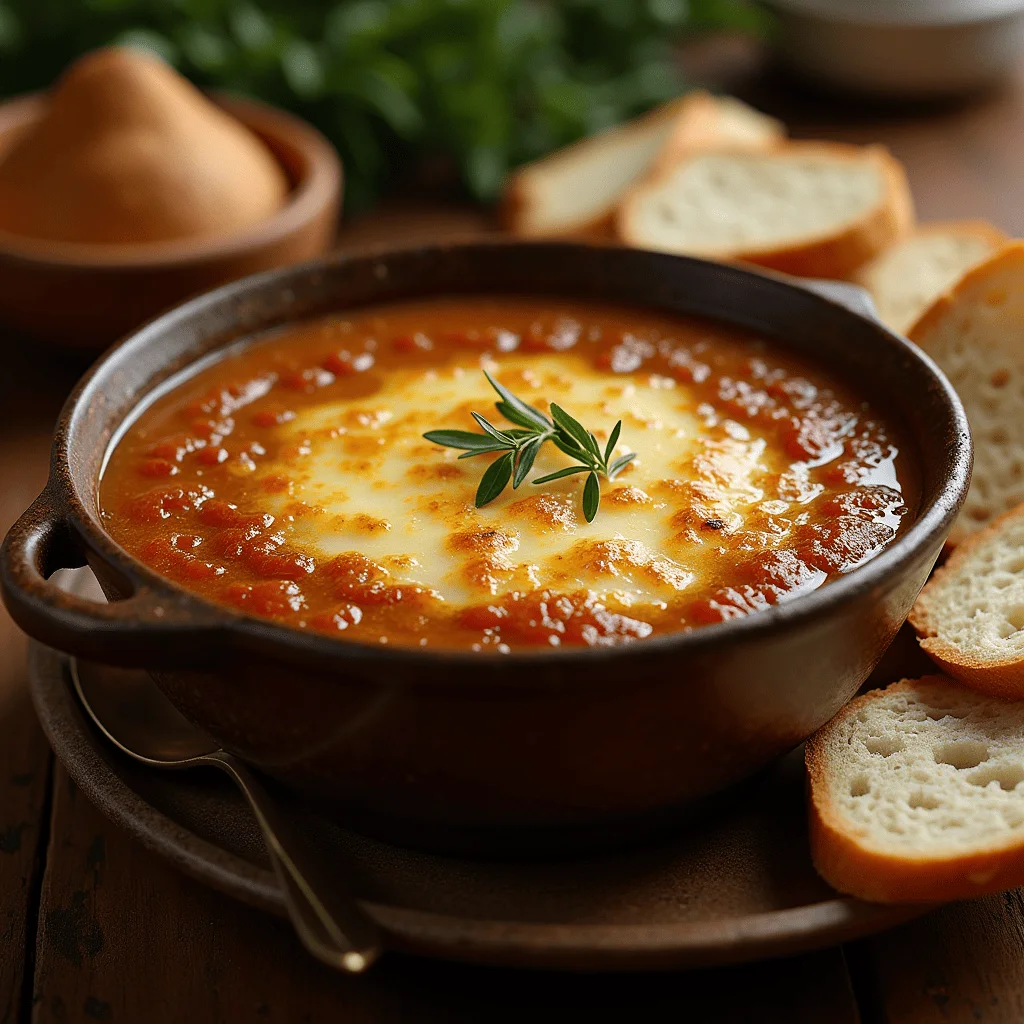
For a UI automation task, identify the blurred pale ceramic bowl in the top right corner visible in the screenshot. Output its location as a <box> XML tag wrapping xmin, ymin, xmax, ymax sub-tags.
<box><xmin>764</xmin><ymin>0</ymin><xmax>1024</xmax><ymax>100</ymax></box>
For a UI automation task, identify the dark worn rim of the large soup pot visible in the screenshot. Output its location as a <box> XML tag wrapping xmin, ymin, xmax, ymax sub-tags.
<box><xmin>47</xmin><ymin>239</ymin><xmax>973</xmax><ymax>675</ymax></box>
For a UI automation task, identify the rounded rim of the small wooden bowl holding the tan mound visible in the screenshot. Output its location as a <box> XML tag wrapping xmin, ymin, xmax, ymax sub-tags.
<box><xmin>0</xmin><ymin>91</ymin><xmax>343</xmax><ymax>273</ymax></box>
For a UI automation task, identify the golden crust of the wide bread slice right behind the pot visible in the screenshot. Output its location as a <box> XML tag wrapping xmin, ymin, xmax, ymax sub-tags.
<box><xmin>615</xmin><ymin>141</ymin><xmax>914</xmax><ymax>278</ymax></box>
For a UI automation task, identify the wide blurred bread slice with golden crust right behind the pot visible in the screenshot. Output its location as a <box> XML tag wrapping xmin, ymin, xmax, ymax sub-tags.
<box><xmin>616</xmin><ymin>142</ymin><xmax>913</xmax><ymax>278</ymax></box>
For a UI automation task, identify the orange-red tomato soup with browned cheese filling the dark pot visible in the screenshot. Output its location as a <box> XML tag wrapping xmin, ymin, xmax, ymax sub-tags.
<box><xmin>99</xmin><ymin>297</ymin><xmax>915</xmax><ymax>653</ymax></box>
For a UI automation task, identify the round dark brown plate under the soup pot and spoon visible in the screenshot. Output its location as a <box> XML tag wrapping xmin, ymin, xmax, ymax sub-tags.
<box><xmin>30</xmin><ymin>645</ymin><xmax>925</xmax><ymax>971</ymax></box>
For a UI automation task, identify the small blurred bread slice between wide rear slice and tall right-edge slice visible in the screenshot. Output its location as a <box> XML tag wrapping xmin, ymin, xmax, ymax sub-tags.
<box><xmin>853</xmin><ymin>220</ymin><xmax>1008</xmax><ymax>334</ymax></box>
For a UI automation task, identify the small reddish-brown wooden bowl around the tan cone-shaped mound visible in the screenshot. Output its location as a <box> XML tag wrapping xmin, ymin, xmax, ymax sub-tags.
<box><xmin>0</xmin><ymin>94</ymin><xmax>342</xmax><ymax>349</ymax></box>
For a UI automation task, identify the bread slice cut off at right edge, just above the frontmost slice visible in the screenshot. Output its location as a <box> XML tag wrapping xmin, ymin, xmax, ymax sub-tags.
<box><xmin>910</xmin><ymin>505</ymin><xmax>1024</xmax><ymax>700</ymax></box>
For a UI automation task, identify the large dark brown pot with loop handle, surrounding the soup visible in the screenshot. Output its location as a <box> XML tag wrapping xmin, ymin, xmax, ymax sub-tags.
<box><xmin>0</xmin><ymin>243</ymin><xmax>971</xmax><ymax>853</ymax></box>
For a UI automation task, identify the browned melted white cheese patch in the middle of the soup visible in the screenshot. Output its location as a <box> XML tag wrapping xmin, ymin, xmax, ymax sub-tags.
<box><xmin>263</xmin><ymin>353</ymin><xmax>774</xmax><ymax>604</ymax></box>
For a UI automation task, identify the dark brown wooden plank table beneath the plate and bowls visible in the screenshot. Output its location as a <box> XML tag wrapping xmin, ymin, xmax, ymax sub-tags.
<box><xmin>6</xmin><ymin>44</ymin><xmax>1024</xmax><ymax>1024</ymax></box>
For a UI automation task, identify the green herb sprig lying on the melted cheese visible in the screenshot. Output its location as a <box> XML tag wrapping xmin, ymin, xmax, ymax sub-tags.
<box><xmin>423</xmin><ymin>370</ymin><xmax>637</xmax><ymax>522</ymax></box>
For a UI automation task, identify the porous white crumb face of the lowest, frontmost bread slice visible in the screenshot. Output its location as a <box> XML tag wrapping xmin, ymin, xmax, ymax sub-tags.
<box><xmin>812</xmin><ymin>676</ymin><xmax>1024</xmax><ymax>859</ymax></box>
